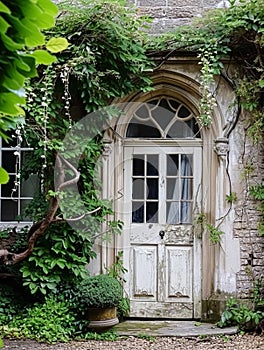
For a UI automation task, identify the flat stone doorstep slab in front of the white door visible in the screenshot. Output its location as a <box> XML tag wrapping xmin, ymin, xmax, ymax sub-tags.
<box><xmin>114</xmin><ymin>320</ymin><xmax>237</xmax><ymax>337</ymax></box>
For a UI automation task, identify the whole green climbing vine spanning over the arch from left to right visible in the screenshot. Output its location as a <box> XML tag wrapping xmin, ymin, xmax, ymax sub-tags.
<box><xmin>0</xmin><ymin>0</ymin><xmax>264</xmax><ymax>292</ymax></box>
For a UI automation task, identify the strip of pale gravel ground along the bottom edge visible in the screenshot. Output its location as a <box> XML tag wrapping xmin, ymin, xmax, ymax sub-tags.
<box><xmin>2</xmin><ymin>334</ymin><xmax>264</xmax><ymax>350</ymax></box>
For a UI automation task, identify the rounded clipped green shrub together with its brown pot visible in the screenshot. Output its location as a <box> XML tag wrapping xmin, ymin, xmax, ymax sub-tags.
<box><xmin>76</xmin><ymin>274</ymin><xmax>122</xmax><ymax>331</ymax></box>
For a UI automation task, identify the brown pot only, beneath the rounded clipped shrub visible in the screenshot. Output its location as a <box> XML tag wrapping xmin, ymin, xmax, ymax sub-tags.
<box><xmin>87</xmin><ymin>307</ymin><xmax>119</xmax><ymax>331</ymax></box>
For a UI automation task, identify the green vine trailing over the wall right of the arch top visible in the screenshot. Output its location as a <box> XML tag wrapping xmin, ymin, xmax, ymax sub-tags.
<box><xmin>151</xmin><ymin>0</ymin><xmax>264</xmax><ymax>133</ymax></box>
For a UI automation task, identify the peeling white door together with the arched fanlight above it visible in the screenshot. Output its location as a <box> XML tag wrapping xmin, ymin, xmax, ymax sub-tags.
<box><xmin>120</xmin><ymin>95</ymin><xmax>202</xmax><ymax>318</ymax></box>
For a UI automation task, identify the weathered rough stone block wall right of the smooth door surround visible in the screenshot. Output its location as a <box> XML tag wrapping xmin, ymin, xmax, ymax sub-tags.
<box><xmin>231</xmin><ymin>117</ymin><xmax>264</xmax><ymax>298</ymax></box>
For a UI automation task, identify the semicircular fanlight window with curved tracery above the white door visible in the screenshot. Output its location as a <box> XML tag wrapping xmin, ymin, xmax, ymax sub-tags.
<box><xmin>126</xmin><ymin>97</ymin><xmax>201</xmax><ymax>139</ymax></box>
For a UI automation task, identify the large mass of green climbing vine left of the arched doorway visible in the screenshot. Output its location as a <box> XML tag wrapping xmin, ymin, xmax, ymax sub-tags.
<box><xmin>11</xmin><ymin>0</ymin><xmax>153</xmax><ymax>294</ymax></box>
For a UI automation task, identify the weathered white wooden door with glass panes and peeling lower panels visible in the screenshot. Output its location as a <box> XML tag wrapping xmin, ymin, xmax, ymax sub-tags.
<box><xmin>124</xmin><ymin>145</ymin><xmax>201</xmax><ymax>318</ymax></box>
